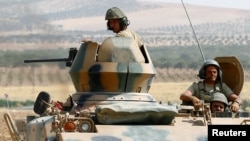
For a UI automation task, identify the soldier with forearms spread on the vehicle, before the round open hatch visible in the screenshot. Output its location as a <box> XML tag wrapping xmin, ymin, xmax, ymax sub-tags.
<box><xmin>180</xmin><ymin>60</ymin><xmax>242</xmax><ymax>112</ymax></box>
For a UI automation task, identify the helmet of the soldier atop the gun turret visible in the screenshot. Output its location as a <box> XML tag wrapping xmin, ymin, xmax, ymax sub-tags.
<box><xmin>105</xmin><ymin>7</ymin><xmax>126</xmax><ymax>20</ymax></box>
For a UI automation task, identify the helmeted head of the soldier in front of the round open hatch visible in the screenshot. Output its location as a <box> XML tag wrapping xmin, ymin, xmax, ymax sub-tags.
<box><xmin>198</xmin><ymin>60</ymin><xmax>222</xmax><ymax>81</ymax></box>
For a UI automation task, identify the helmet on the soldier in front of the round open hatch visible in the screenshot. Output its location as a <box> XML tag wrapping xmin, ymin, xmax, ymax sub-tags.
<box><xmin>198</xmin><ymin>59</ymin><xmax>222</xmax><ymax>81</ymax></box>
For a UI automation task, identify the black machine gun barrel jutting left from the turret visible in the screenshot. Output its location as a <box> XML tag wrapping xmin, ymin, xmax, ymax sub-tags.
<box><xmin>24</xmin><ymin>48</ymin><xmax>78</xmax><ymax>67</ymax></box>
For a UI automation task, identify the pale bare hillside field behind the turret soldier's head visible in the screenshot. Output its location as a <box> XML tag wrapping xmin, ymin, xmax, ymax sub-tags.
<box><xmin>52</xmin><ymin>2</ymin><xmax>249</xmax><ymax>31</ymax></box>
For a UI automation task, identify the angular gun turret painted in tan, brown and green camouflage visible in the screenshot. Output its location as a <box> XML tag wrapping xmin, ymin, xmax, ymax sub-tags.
<box><xmin>69</xmin><ymin>37</ymin><xmax>156</xmax><ymax>93</ymax></box>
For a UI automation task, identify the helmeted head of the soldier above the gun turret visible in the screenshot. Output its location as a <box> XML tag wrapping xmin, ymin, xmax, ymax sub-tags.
<box><xmin>105</xmin><ymin>7</ymin><xmax>129</xmax><ymax>33</ymax></box>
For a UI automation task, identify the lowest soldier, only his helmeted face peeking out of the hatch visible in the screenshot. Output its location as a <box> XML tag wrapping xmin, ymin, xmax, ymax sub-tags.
<box><xmin>210</xmin><ymin>92</ymin><xmax>228</xmax><ymax>113</ymax></box>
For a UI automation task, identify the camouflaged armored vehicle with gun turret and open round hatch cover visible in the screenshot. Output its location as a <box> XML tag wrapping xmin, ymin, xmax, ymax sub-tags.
<box><xmin>4</xmin><ymin>37</ymin><xmax>249</xmax><ymax>141</ymax></box>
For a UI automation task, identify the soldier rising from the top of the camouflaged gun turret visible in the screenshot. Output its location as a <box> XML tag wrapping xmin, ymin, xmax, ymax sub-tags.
<box><xmin>105</xmin><ymin>7</ymin><xmax>142</xmax><ymax>47</ymax></box>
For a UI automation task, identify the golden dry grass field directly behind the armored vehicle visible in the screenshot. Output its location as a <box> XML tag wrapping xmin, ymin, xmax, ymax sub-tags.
<box><xmin>0</xmin><ymin>82</ymin><xmax>250</xmax><ymax>103</ymax></box>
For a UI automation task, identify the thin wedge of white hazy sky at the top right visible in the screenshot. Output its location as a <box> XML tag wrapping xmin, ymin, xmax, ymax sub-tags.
<box><xmin>141</xmin><ymin>0</ymin><xmax>250</xmax><ymax>10</ymax></box>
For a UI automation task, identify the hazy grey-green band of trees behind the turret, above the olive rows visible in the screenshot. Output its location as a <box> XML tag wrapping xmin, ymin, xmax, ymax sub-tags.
<box><xmin>0</xmin><ymin>45</ymin><xmax>250</xmax><ymax>70</ymax></box>
